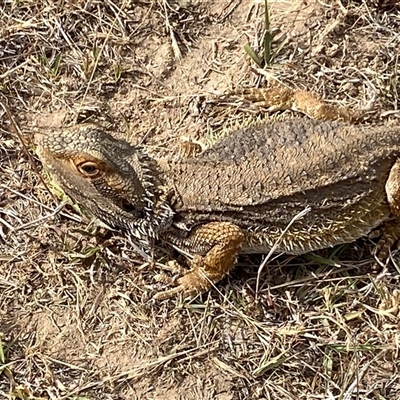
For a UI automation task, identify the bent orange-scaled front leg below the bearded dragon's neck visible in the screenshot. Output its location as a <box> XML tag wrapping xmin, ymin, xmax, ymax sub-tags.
<box><xmin>154</xmin><ymin>222</ymin><xmax>244</xmax><ymax>300</ymax></box>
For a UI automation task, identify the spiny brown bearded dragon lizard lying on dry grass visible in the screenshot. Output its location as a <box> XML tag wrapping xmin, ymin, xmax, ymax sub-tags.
<box><xmin>37</xmin><ymin>112</ymin><xmax>400</xmax><ymax>299</ymax></box>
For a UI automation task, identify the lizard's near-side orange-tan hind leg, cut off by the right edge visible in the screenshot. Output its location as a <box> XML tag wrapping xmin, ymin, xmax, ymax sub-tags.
<box><xmin>376</xmin><ymin>159</ymin><xmax>400</xmax><ymax>263</ymax></box>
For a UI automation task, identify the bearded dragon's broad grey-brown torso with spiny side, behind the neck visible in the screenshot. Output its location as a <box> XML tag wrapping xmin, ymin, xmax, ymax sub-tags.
<box><xmin>169</xmin><ymin>119</ymin><xmax>400</xmax><ymax>253</ymax></box>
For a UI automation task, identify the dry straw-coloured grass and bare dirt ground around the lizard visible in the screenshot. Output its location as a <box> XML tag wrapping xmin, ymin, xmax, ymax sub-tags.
<box><xmin>0</xmin><ymin>0</ymin><xmax>400</xmax><ymax>400</ymax></box>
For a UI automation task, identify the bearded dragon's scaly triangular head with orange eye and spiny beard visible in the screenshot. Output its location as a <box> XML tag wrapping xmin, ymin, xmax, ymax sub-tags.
<box><xmin>35</xmin><ymin>124</ymin><xmax>165</xmax><ymax>238</ymax></box>
